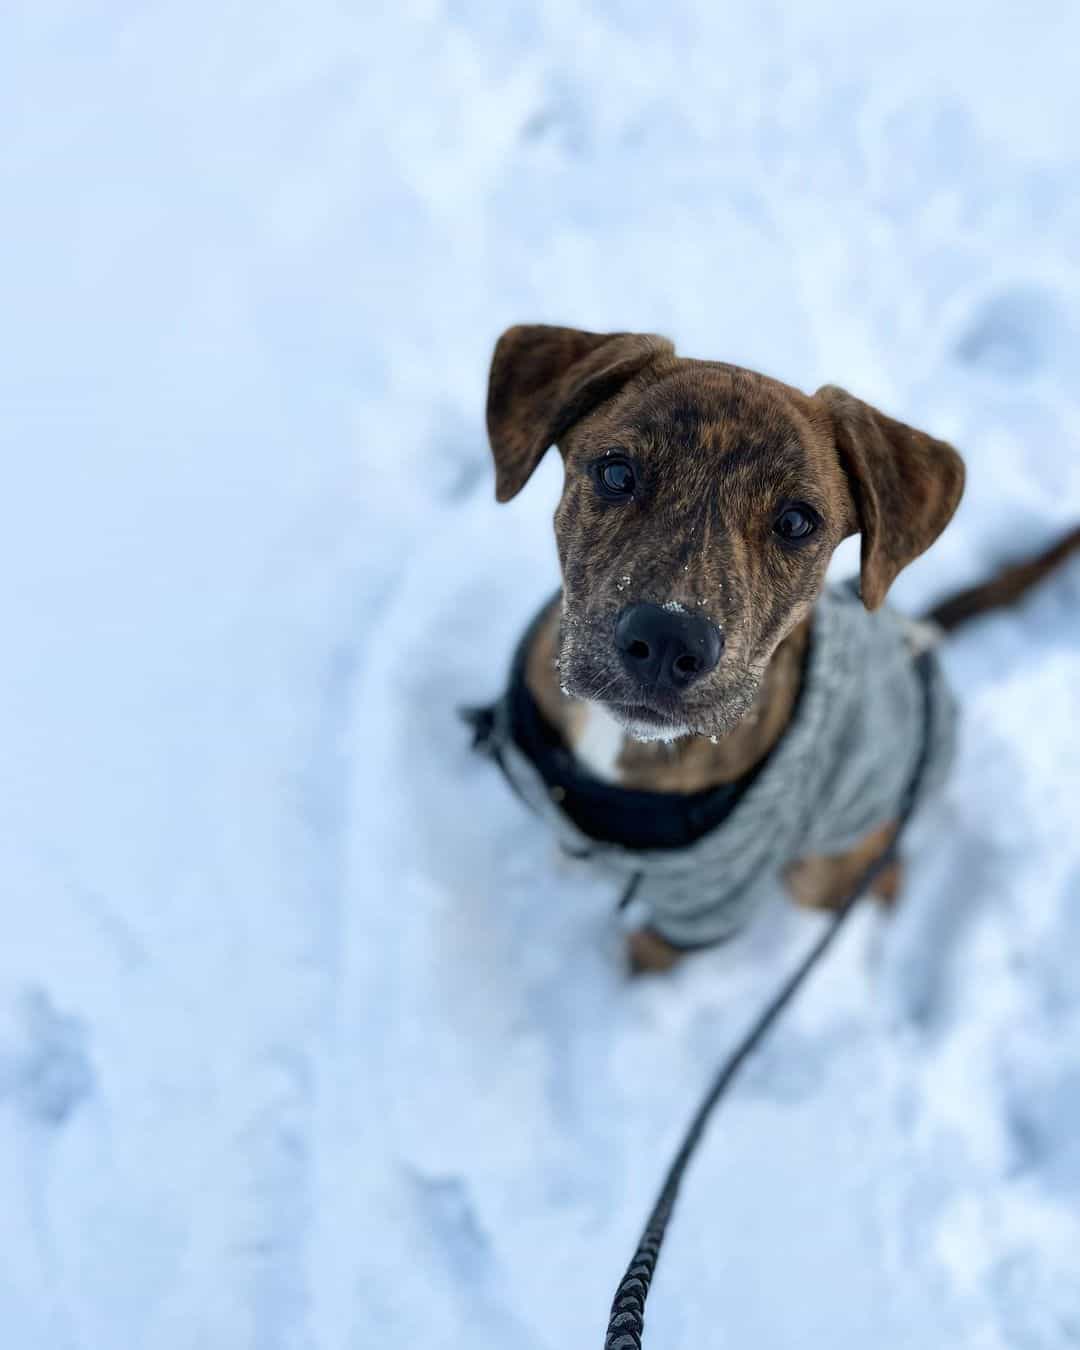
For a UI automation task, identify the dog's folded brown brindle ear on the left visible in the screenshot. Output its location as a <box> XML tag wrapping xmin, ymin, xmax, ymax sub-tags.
<box><xmin>487</xmin><ymin>324</ymin><xmax>675</xmax><ymax>502</ymax></box>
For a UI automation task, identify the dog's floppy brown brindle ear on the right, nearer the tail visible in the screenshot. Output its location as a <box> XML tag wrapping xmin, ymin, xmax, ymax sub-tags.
<box><xmin>814</xmin><ymin>385</ymin><xmax>964</xmax><ymax>609</ymax></box>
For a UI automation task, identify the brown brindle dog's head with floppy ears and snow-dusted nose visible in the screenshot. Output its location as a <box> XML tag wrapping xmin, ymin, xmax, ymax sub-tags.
<box><xmin>487</xmin><ymin>325</ymin><xmax>964</xmax><ymax>740</ymax></box>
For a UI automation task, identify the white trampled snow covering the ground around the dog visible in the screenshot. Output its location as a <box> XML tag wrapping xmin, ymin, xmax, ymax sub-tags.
<box><xmin>0</xmin><ymin>0</ymin><xmax>1080</xmax><ymax>1350</ymax></box>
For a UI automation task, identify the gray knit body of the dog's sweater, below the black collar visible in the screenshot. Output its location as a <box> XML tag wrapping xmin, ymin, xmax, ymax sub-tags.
<box><xmin>477</xmin><ymin>587</ymin><xmax>954</xmax><ymax>948</ymax></box>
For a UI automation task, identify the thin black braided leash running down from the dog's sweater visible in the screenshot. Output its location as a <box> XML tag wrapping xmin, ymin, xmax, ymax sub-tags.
<box><xmin>603</xmin><ymin>655</ymin><xmax>933</xmax><ymax>1350</ymax></box>
